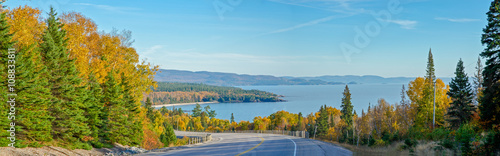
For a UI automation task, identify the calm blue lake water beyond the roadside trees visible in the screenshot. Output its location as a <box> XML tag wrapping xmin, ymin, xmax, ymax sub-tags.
<box><xmin>162</xmin><ymin>84</ymin><xmax>403</xmax><ymax>121</ymax></box>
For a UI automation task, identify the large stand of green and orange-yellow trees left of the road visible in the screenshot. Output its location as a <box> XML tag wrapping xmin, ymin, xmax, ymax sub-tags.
<box><xmin>0</xmin><ymin>6</ymin><xmax>169</xmax><ymax>149</ymax></box>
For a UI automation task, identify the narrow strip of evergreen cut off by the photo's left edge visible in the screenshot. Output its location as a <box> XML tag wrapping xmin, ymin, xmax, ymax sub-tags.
<box><xmin>0</xmin><ymin>12</ymin><xmax>14</xmax><ymax>147</ymax></box>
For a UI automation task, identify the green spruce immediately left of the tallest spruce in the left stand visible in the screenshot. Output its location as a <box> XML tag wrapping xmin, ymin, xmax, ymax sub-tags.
<box><xmin>16</xmin><ymin>45</ymin><xmax>53</xmax><ymax>147</ymax></box>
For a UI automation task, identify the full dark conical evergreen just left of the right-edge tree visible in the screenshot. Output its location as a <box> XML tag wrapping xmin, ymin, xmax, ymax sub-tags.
<box><xmin>447</xmin><ymin>59</ymin><xmax>474</xmax><ymax>128</ymax></box>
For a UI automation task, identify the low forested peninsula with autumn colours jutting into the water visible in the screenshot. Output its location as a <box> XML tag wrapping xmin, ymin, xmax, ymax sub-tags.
<box><xmin>144</xmin><ymin>82</ymin><xmax>283</xmax><ymax>104</ymax></box>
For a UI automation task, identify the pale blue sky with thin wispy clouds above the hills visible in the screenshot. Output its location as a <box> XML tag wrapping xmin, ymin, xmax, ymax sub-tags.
<box><xmin>5</xmin><ymin>0</ymin><xmax>491</xmax><ymax>77</ymax></box>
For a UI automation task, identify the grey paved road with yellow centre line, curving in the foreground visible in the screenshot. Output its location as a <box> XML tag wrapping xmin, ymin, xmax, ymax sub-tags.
<box><xmin>138</xmin><ymin>133</ymin><xmax>352</xmax><ymax>156</ymax></box>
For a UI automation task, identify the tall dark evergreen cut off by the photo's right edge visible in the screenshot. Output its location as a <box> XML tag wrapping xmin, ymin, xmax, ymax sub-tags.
<box><xmin>479</xmin><ymin>0</ymin><xmax>500</xmax><ymax>129</ymax></box>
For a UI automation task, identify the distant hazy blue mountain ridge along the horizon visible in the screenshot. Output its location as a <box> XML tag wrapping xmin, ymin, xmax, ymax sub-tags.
<box><xmin>155</xmin><ymin>69</ymin><xmax>451</xmax><ymax>86</ymax></box>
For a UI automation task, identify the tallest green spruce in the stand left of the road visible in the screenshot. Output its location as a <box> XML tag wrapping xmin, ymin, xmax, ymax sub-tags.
<box><xmin>40</xmin><ymin>8</ymin><xmax>90</xmax><ymax>148</ymax></box>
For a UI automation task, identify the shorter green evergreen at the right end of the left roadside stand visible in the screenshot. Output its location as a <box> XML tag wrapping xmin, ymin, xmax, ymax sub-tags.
<box><xmin>102</xmin><ymin>70</ymin><xmax>130</xmax><ymax>145</ymax></box>
